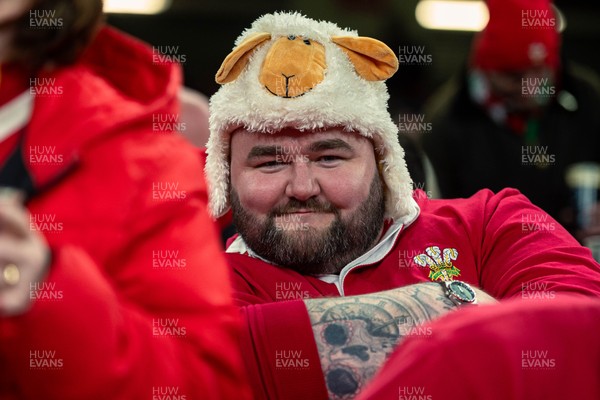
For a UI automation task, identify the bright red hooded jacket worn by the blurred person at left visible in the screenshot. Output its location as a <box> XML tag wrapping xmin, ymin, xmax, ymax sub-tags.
<box><xmin>0</xmin><ymin>29</ymin><xmax>247</xmax><ymax>400</ymax></box>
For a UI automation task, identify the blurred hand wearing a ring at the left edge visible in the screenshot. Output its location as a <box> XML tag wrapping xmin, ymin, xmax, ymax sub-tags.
<box><xmin>0</xmin><ymin>188</ymin><xmax>50</xmax><ymax>316</ymax></box>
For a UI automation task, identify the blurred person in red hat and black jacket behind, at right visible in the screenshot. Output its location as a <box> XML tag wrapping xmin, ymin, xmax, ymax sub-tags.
<box><xmin>422</xmin><ymin>0</ymin><xmax>600</xmax><ymax>250</ymax></box>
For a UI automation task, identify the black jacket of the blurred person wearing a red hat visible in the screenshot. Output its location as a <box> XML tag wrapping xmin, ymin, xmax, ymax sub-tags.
<box><xmin>422</xmin><ymin>61</ymin><xmax>600</xmax><ymax>231</ymax></box>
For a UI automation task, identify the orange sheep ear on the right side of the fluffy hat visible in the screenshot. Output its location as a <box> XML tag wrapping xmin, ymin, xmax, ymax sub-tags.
<box><xmin>331</xmin><ymin>36</ymin><xmax>398</xmax><ymax>81</ymax></box>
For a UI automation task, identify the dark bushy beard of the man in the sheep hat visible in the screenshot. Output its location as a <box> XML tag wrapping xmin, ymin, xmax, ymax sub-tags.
<box><xmin>231</xmin><ymin>173</ymin><xmax>385</xmax><ymax>275</ymax></box>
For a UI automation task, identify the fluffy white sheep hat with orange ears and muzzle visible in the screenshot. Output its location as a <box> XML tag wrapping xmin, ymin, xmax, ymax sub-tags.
<box><xmin>205</xmin><ymin>12</ymin><xmax>419</xmax><ymax>223</ymax></box>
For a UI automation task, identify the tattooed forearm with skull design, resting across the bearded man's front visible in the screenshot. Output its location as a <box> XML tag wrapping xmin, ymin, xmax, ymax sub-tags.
<box><xmin>305</xmin><ymin>282</ymin><xmax>495</xmax><ymax>399</ymax></box>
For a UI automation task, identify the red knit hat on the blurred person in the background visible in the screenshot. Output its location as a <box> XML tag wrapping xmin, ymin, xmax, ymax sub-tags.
<box><xmin>471</xmin><ymin>0</ymin><xmax>560</xmax><ymax>71</ymax></box>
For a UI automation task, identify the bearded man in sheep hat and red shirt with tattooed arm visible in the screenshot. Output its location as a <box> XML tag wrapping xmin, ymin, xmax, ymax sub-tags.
<box><xmin>206</xmin><ymin>13</ymin><xmax>600</xmax><ymax>400</ymax></box>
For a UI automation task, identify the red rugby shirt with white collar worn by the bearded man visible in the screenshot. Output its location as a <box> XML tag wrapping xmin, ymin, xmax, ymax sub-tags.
<box><xmin>227</xmin><ymin>189</ymin><xmax>600</xmax><ymax>400</ymax></box>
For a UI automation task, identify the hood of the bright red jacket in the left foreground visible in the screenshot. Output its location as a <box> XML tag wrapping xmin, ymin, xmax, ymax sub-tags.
<box><xmin>23</xmin><ymin>27</ymin><xmax>181</xmax><ymax>186</ymax></box>
